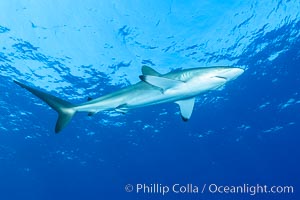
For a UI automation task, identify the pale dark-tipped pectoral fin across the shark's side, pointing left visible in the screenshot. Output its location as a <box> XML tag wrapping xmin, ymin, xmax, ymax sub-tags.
<box><xmin>140</xmin><ymin>75</ymin><xmax>184</xmax><ymax>91</ymax></box>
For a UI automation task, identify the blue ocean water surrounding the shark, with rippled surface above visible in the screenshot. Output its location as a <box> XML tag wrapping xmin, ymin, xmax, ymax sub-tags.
<box><xmin>0</xmin><ymin>0</ymin><xmax>300</xmax><ymax>200</ymax></box>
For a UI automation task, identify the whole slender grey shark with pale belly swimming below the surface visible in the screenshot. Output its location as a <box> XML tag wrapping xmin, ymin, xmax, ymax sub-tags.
<box><xmin>14</xmin><ymin>66</ymin><xmax>244</xmax><ymax>133</ymax></box>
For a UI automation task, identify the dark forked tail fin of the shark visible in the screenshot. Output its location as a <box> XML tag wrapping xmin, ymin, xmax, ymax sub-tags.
<box><xmin>14</xmin><ymin>81</ymin><xmax>76</xmax><ymax>133</ymax></box>
